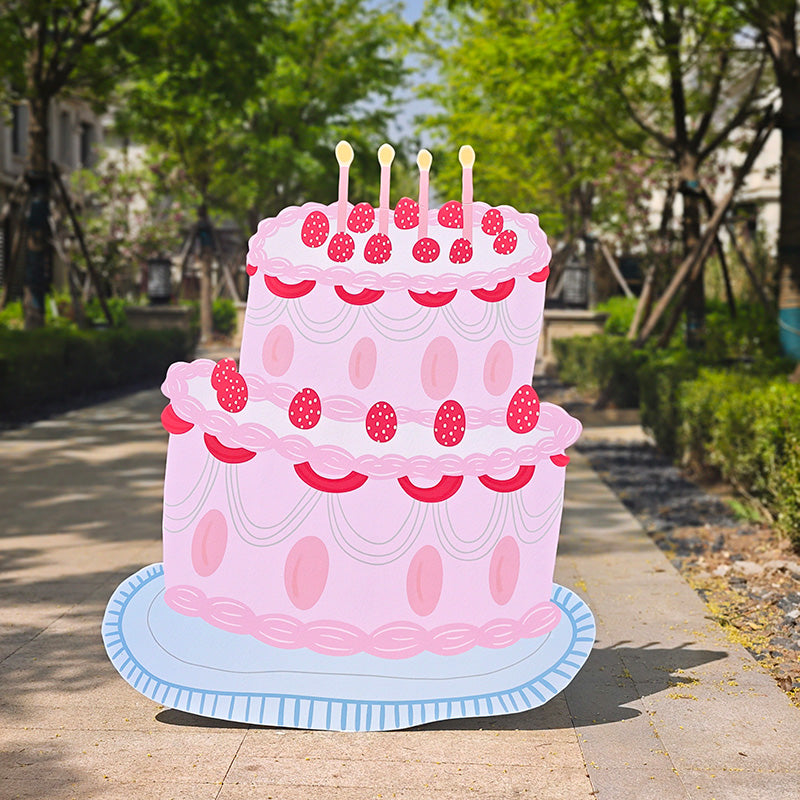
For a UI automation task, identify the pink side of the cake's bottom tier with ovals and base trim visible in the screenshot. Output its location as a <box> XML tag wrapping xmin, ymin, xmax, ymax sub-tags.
<box><xmin>163</xmin><ymin>429</ymin><xmax>565</xmax><ymax>658</ymax></box>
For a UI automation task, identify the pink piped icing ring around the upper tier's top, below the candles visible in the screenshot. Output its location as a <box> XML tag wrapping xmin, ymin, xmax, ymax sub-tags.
<box><xmin>247</xmin><ymin>203</ymin><xmax>551</xmax><ymax>292</ymax></box>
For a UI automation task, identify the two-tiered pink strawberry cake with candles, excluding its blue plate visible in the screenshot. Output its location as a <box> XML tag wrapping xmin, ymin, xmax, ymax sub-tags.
<box><xmin>156</xmin><ymin>145</ymin><xmax>580</xmax><ymax>658</ymax></box>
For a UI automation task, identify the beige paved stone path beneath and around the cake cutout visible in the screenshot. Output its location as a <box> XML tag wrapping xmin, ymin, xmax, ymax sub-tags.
<box><xmin>0</xmin><ymin>390</ymin><xmax>800</xmax><ymax>800</ymax></box>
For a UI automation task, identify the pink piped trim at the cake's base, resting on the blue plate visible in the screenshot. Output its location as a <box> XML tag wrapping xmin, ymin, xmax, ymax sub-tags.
<box><xmin>164</xmin><ymin>586</ymin><xmax>561</xmax><ymax>658</ymax></box>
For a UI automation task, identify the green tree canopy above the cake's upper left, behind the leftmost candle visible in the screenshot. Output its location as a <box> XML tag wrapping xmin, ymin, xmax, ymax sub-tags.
<box><xmin>120</xmin><ymin>0</ymin><xmax>407</xmax><ymax>225</ymax></box>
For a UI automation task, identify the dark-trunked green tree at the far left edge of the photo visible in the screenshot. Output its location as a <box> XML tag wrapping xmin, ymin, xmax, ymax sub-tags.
<box><xmin>0</xmin><ymin>0</ymin><xmax>144</xmax><ymax>327</ymax></box>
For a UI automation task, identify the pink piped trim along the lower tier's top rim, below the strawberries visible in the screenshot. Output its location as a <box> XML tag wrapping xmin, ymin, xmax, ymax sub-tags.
<box><xmin>161</xmin><ymin>359</ymin><xmax>581</xmax><ymax>478</ymax></box>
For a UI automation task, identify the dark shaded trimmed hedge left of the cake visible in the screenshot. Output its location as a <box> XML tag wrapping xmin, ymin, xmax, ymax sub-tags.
<box><xmin>0</xmin><ymin>328</ymin><xmax>193</xmax><ymax>420</ymax></box>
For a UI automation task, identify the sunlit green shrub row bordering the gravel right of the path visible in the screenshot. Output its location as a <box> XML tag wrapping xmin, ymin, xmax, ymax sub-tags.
<box><xmin>553</xmin><ymin>328</ymin><xmax>800</xmax><ymax>548</ymax></box>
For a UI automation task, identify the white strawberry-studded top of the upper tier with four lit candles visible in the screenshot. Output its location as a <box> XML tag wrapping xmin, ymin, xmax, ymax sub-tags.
<box><xmin>247</xmin><ymin>142</ymin><xmax>551</xmax><ymax>292</ymax></box>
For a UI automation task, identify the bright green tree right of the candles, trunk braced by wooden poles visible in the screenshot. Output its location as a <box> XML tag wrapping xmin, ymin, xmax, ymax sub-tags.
<box><xmin>424</xmin><ymin>0</ymin><xmax>763</xmax><ymax>341</ymax></box>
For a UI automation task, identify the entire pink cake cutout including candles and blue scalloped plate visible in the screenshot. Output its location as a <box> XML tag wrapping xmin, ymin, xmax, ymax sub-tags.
<box><xmin>103</xmin><ymin>142</ymin><xmax>594</xmax><ymax>730</ymax></box>
